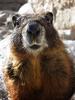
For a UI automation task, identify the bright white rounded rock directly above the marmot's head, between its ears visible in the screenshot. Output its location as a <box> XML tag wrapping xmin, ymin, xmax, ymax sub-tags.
<box><xmin>18</xmin><ymin>2</ymin><xmax>45</xmax><ymax>15</ymax></box>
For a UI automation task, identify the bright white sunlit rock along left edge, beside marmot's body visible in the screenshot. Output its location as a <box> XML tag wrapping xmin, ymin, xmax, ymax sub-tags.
<box><xmin>0</xmin><ymin>36</ymin><xmax>10</xmax><ymax>100</ymax></box>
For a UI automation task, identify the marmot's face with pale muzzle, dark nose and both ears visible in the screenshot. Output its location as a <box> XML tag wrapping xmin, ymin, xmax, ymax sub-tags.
<box><xmin>12</xmin><ymin>12</ymin><xmax>53</xmax><ymax>53</ymax></box>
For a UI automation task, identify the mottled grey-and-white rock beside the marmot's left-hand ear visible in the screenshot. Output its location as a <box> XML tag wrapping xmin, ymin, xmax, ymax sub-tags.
<box><xmin>0</xmin><ymin>10</ymin><xmax>15</xmax><ymax>40</ymax></box>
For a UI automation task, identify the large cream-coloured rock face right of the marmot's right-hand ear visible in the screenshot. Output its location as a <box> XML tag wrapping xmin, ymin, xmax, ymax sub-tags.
<box><xmin>55</xmin><ymin>7</ymin><xmax>75</xmax><ymax>29</ymax></box>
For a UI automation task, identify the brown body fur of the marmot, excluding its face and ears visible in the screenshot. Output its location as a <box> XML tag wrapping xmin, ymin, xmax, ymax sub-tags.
<box><xmin>4</xmin><ymin>12</ymin><xmax>73</xmax><ymax>100</ymax></box>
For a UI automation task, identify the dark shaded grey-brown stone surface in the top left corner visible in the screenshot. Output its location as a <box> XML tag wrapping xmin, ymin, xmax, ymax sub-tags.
<box><xmin>0</xmin><ymin>0</ymin><xmax>27</xmax><ymax>11</ymax></box>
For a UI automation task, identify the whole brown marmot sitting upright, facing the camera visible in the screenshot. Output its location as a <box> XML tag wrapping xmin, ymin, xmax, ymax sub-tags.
<box><xmin>4</xmin><ymin>12</ymin><xmax>74</xmax><ymax>100</ymax></box>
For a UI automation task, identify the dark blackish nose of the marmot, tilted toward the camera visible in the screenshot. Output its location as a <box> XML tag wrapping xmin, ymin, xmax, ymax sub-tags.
<box><xmin>27</xmin><ymin>21</ymin><xmax>40</xmax><ymax>37</ymax></box>
